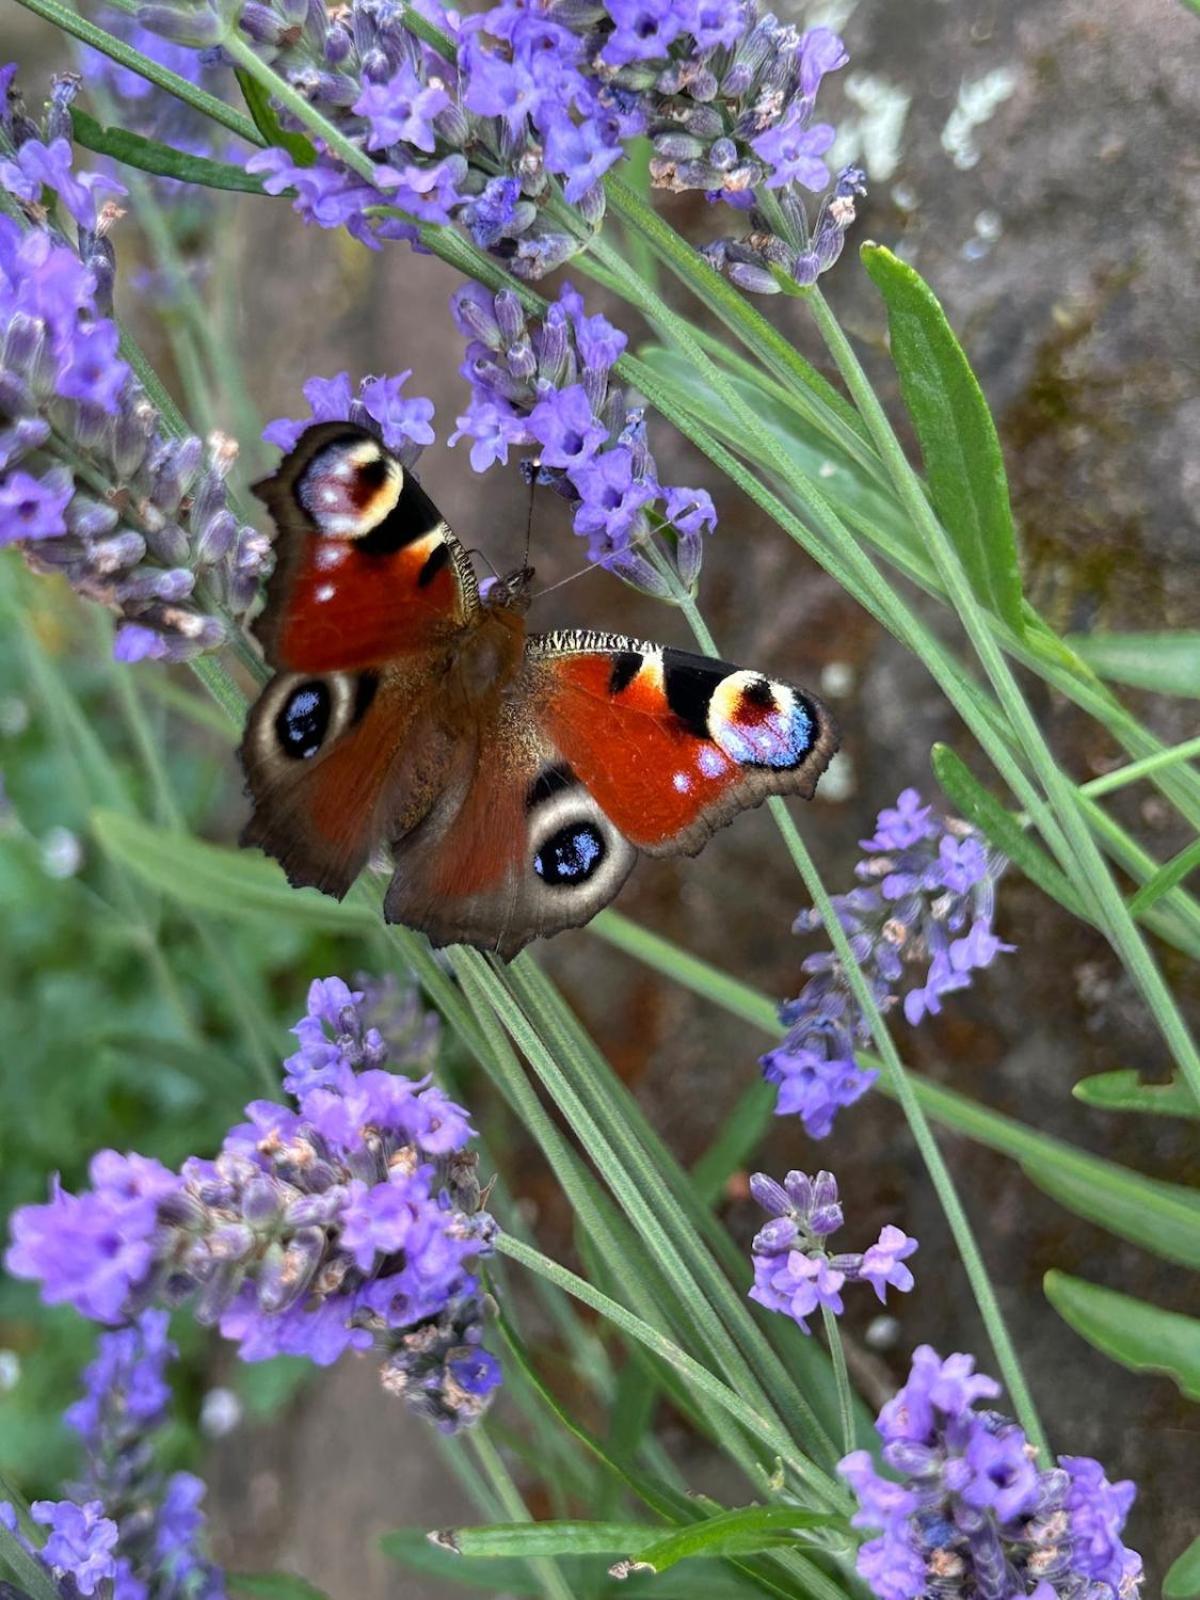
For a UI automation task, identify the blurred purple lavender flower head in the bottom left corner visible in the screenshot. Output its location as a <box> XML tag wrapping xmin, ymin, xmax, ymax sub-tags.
<box><xmin>0</xmin><ymin>1310</ymin><xmax>226</xmax><ymax>1600</ymax></box>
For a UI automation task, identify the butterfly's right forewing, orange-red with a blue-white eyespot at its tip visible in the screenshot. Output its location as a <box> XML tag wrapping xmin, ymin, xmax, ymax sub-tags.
<box><xmin>528</xmin><ymin>632</ymin><xmax>837</xmax><ymax>856</ymax></box>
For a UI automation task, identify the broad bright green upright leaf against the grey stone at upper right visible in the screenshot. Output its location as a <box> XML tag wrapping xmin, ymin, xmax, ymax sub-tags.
<box><xmin>862</xmin><ymin>245</ymin><xmax>1024</xmax><ymax>637</ymax></box>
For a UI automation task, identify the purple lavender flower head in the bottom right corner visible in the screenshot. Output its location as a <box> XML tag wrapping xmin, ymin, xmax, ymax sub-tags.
<box><xmin>838</xmin><ymin>1344</ymin><xmax>1142</xmax><ymax>1600</ymax></box>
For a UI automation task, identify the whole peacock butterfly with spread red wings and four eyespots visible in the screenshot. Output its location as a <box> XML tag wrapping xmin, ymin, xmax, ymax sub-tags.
<box><xmin>240</xmin><ymin>422</ymin><xmax>837</xmax><ymax>958</ymax></box>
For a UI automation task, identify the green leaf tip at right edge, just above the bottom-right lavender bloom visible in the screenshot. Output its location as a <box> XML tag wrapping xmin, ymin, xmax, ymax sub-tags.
<box><xmin>1042</xmin><ymin>1272</ymin><xmax>1200</xmax><ymax>1400</ymax></box>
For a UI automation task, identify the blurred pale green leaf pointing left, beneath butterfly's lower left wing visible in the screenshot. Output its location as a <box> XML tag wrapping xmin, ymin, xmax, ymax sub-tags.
<box><xmin>91</xmin><ymin>811</ymin><xmax>379</xmax><ymax>933</ymax></box>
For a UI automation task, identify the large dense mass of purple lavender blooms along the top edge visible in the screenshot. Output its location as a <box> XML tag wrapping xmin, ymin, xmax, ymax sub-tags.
<box><xmin>139</xmin><ymin>0</ymin><xmax>862</xmax><ymax>293</ymax></box>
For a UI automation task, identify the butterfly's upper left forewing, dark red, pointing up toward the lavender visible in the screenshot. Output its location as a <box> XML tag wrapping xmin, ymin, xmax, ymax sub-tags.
<box><xmin>254</xmin><ymin>422</ymin><xmax>478</xmax><ymax>674</ymax></box>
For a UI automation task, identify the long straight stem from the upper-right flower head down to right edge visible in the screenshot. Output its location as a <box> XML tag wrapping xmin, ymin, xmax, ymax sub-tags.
<box><xmin>808</xmin><ymin>290</ymin><xmax>1200</xmax><ymax>1102</ymax></box>
